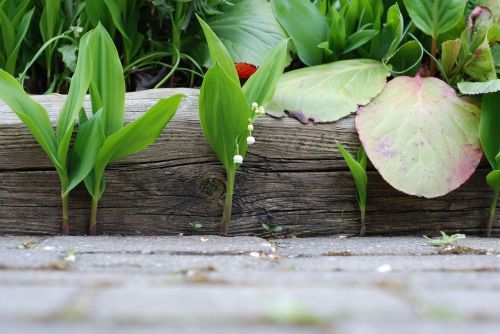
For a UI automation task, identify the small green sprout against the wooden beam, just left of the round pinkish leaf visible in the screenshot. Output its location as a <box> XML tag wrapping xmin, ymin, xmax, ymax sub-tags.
<box><xmin>336</xmin><ymin>141</ymin><xmax>368</xmax><ymax>237</ymax></box>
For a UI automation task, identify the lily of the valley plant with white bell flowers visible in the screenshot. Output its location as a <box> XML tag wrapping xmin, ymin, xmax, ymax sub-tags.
<box><xmin>198</xmin><ymin>18</ymin><xmax>287</xmax><ymax>234</ymax></box>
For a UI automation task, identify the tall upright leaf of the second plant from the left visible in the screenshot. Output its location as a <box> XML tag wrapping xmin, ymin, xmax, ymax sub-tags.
<box><xmin>89</xmin><ymin>24</ymin><xmax>125</xmax><ymax>136</ymax></box>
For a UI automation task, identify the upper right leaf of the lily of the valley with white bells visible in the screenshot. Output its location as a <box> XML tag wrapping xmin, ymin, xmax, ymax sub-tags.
<box><xmin>243</xmin><ymin>40</ymin><xmax>287</xmax><ymax>105</ymax></box>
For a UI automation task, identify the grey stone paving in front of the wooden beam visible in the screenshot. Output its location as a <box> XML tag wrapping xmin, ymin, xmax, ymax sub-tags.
<box><xmin>0</xmin><ymin>236</ymin><xmax>500</xmax><ymax>334</ymax></box>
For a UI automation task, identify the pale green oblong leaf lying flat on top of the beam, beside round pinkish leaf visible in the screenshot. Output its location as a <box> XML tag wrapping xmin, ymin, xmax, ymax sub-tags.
<box><xmin>267</xmin><ymin>59</ymin><xmax>389</xmax><ymax>123</ymax></box>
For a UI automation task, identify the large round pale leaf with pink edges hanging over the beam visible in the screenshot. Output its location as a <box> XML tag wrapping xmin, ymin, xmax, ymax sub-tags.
<box><xmin>356</xmin><ymin>76</ymin><xmax>482</xmax><ymax>198</ymax></box>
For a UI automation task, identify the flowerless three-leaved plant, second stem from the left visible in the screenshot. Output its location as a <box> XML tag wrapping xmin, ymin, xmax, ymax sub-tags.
<box><xmin>69</xmin><ymin>25</ymin><xmax>183</xmax><ymax>235</ymax></box>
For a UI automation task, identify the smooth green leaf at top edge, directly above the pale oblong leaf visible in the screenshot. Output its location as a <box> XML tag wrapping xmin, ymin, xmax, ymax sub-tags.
<box><xmin>271</xmin><ymin>0</ymin><xmax>328</xmax><ymax>66</ymax></box>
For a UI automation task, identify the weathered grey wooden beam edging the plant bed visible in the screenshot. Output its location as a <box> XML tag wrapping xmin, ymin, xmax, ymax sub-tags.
<box><xmin>0</xmin><ymin>89</ymin><xmax>500</xmax><ymax>236</ymax></box>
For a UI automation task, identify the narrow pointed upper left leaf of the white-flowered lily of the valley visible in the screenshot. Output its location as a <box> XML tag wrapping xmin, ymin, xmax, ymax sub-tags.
<box><xmin>197</xmin><ymin>16</ymin><xmax>240</xmax><ymax>84</ymax></box>
